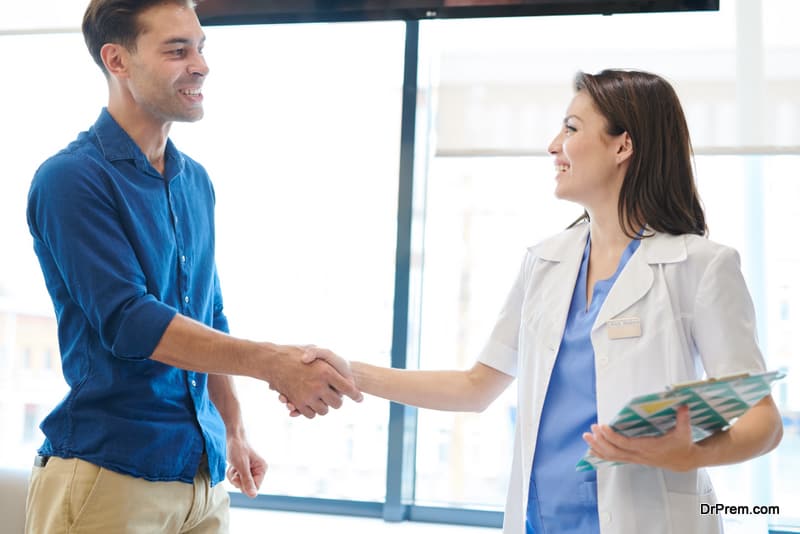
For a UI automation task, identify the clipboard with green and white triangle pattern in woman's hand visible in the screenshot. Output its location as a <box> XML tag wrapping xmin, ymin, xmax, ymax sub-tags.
<box><xmin>575</xmin><ymin>371</ymin><xmax>786</xmax><ymax>471</ymax></box>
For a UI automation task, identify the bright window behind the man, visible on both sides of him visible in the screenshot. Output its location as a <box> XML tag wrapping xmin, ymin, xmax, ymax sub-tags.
<box><xmin>0</xmin><ymin>19</ymin><xmax>404</xmax><ymax>501</ymax></box>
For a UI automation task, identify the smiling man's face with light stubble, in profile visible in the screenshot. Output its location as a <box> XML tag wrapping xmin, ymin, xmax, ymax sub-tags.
<box><xmin>123</xmin><ymin>4</ymin><xmax>208</xmax><ymax>123</ymax></box>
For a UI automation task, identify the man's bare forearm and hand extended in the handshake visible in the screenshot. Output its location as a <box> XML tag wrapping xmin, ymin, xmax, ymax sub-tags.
<box><xmin>150</xmin><ymin>314</ymin><xmax>361</xmax><ymax>418</ymax></box>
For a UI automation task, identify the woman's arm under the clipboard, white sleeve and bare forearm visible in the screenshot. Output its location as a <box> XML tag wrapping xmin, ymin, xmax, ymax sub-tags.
<box><xmin>583</xmin><ymin>247</ymin><xmax>783</xmax><ymax>471</ymax></box>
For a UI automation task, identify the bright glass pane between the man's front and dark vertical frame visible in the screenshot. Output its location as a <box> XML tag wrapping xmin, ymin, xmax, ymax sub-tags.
<box><xmin>173</xmin><ymin>22</ymin><xmax>405</xmax><ymax>501</ymax></box>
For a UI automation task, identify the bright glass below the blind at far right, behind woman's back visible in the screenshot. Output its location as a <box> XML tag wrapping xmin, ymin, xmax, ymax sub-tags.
<box><xmin>697</xmin><ymin>155</ymin><xmax>800</xmax><ymax>531</ymax></box>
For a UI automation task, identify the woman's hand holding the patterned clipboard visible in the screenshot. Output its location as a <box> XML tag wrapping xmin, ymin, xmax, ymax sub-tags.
<box><xmin>583</xmin><ymin>406</ymin><xmax>698</xmax><ymax>471</ymax></box>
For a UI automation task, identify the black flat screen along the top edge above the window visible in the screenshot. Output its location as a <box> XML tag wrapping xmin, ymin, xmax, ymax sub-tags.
<box><xmin>197</xmin><ymin>0</ymin><xmax>719</xmax><ymax>25</ymax></box>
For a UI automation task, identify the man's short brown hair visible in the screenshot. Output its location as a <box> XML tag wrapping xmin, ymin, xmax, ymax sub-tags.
<box><xmin>81</xmin><ymin>0</ymin><xmax>195</xmax><ymax>76</ymax></box>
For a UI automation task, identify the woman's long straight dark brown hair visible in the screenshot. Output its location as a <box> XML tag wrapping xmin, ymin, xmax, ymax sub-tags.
<box><xmin>573</xmin><ymin>70</ymin><xmax>708</xmax><ymax>238</ymax></box>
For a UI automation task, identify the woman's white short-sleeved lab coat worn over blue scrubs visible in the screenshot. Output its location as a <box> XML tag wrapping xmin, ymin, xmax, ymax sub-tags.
<box><xmin>479</xmin><ymin>224</ymin><xmax>764</xmax><ymax>534</ymax></box>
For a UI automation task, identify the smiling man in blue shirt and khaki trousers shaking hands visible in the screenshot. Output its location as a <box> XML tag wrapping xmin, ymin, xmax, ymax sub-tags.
<box><xmin>26</xmin><ymin>0</ymin><xmax>360</xmax><ymax>534</ymax></box>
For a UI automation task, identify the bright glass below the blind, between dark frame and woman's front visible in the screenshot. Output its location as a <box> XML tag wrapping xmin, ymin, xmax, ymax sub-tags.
<box><xmin>412</xmin><ymin>157</ymin><xmax>582</xmax><ymax>509</ymax></box>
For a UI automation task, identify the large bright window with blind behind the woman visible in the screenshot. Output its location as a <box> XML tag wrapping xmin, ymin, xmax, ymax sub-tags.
<box><xmin>411</xmin><ymin>0</ymin><xmax>800</xmax><ymax>528</ymax></box>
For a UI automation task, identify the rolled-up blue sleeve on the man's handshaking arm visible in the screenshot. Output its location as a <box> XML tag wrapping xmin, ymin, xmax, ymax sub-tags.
<box><xmin>28</xmin><ymin>154</ymin><xmax>177</xmax><ymax>359</ymax></box>
